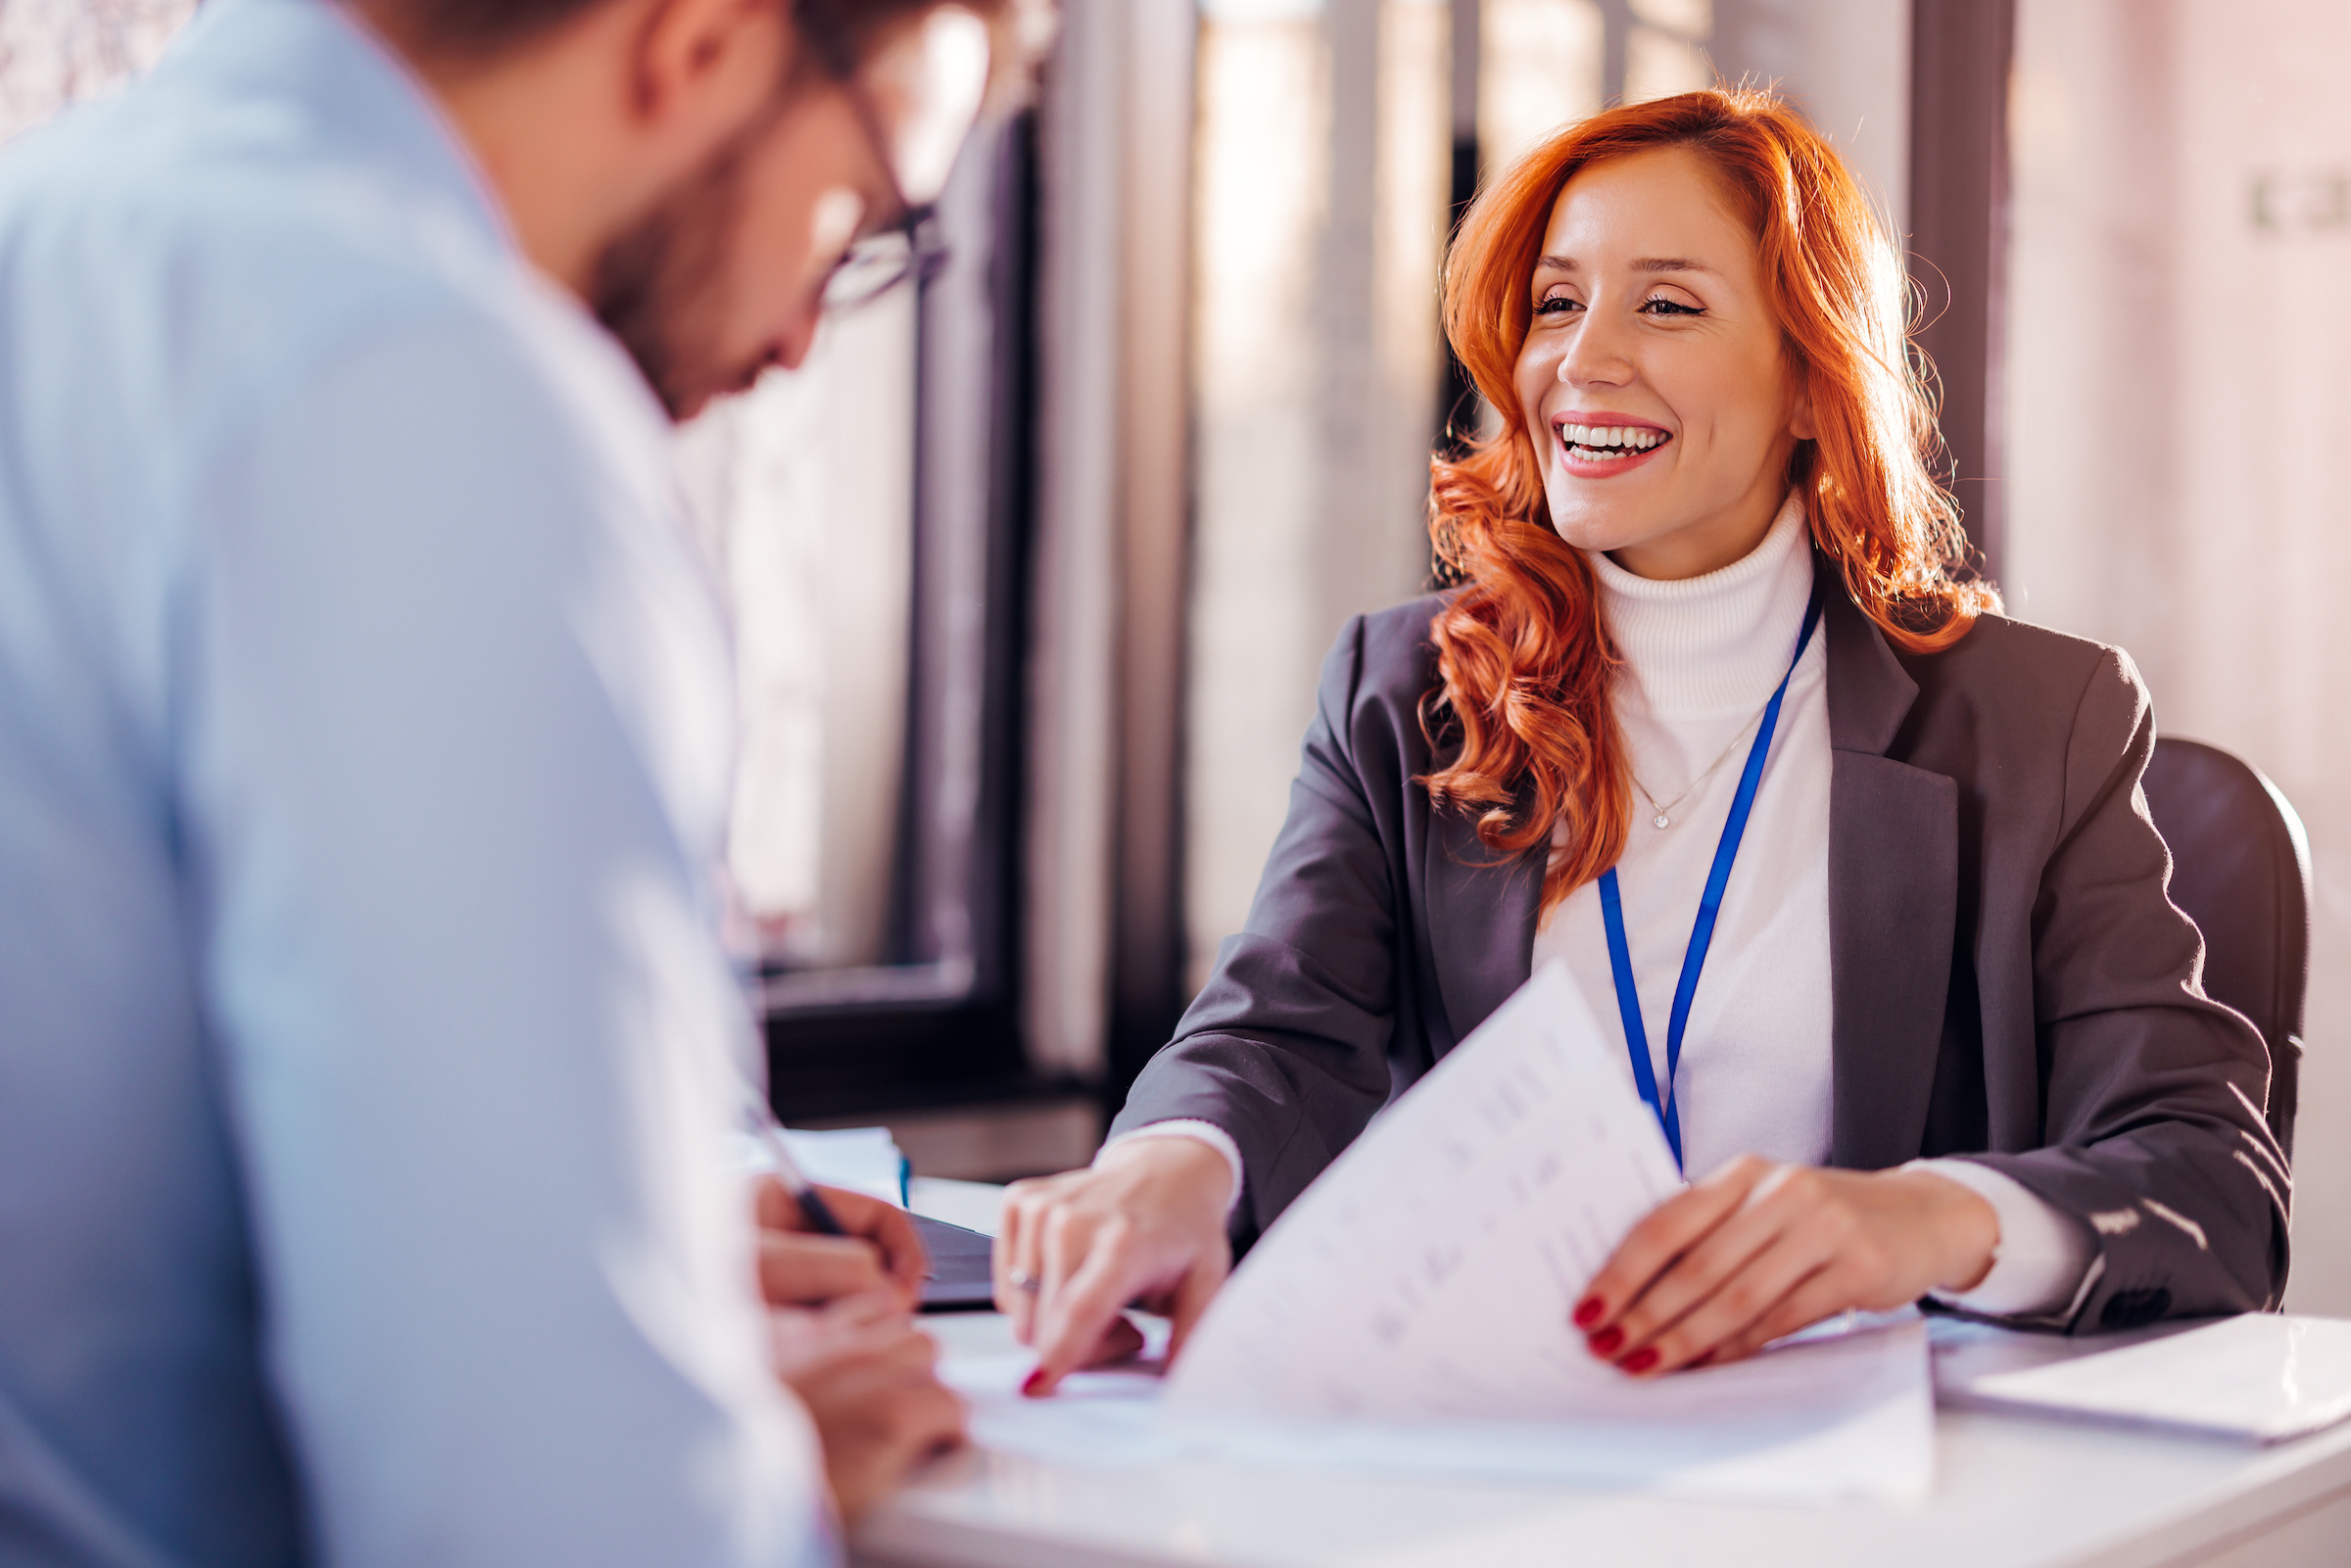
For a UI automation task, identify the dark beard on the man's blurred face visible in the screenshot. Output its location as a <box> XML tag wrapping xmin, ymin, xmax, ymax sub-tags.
<box><xmin>588</xmin><ymin>118</ymin><xmax>771</xmax><ymax>421</ymax></box>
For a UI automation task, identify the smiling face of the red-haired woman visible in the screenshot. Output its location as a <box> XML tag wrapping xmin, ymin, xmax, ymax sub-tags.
<box><xmin>1516</xmin><ymin>148</ymin><xmax>1812</xmax><ymax>578</ymax></box>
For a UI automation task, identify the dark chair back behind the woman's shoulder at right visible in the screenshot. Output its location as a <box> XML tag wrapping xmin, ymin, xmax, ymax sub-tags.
<box><xmin>2144</xmin><ymin>736</ymin><xmax>2311</xmax><ymax>1155</ymax></box>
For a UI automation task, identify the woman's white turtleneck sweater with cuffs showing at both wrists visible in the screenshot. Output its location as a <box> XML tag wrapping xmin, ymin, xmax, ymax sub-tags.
<box><xmin>1124</xmin><ymin>496</ymin><xmax>2092</xmax><ymax>1316</ymax></box>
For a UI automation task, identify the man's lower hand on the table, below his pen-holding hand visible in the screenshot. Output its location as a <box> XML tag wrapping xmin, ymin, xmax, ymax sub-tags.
<box><xmin>769</xmin><ymin>1297</ymin><xmax>964</xmax><ymax>1526</ymax></box>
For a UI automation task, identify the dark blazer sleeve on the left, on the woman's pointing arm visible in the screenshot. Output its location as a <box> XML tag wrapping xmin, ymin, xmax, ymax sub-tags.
<box><xmin>1110</xmin><ymin>616</ymin><xmax>1401</xmax><ymax>1239</ymax></box>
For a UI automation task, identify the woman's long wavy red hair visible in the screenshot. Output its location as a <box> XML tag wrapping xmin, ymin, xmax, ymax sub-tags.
<box><xmin>1422</xmin><ymin>89</ymin><xmax>2000</xmax><ymax>910</ymax></box>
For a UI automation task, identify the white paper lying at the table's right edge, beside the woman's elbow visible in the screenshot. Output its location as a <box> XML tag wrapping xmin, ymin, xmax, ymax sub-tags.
<box><xmin>1965</xmin><ymin>1311</ymin><xmax>2351</xmax><ymax>1444</ymax></box>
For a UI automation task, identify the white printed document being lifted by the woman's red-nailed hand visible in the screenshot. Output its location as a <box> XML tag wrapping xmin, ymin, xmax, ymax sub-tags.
<box><xmin>950</xmin><ymin>967</ymin><xmax>1933</xmax><ymax>1497</ymax></box>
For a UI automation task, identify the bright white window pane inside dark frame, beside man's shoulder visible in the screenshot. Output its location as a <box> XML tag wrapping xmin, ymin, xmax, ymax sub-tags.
<box><xmin>680</xmin><ymin>289</ymin><xmax>922</xmax><ymax>973</ymax></box>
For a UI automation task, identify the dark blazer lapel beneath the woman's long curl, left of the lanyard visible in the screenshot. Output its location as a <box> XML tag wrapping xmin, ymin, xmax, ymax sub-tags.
<box><xmin>1422</xmin><ymin>811</ymin><xmax>1547</xmax><ymax>1056</ymax></box>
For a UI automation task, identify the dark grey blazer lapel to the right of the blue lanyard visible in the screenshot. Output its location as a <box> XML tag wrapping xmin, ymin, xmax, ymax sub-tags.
<box><xmin>1817</xmin><ymin>559</ymin><xmax>1958</xmax><ymax>1170</ymax></box>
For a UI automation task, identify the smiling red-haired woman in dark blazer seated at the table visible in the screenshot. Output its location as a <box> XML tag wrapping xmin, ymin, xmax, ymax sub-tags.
<box><xmin>997</xmin><ymin>92</ymin><xmax>2287</xmax><ymax>1392</ymax></box>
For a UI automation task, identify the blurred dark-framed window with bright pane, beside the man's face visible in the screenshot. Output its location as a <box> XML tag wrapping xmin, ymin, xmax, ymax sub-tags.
<box><xmin>714</xmin><ymin>119</ymin><xmax>1034</xmax><ymax>1117</ymax></box>
